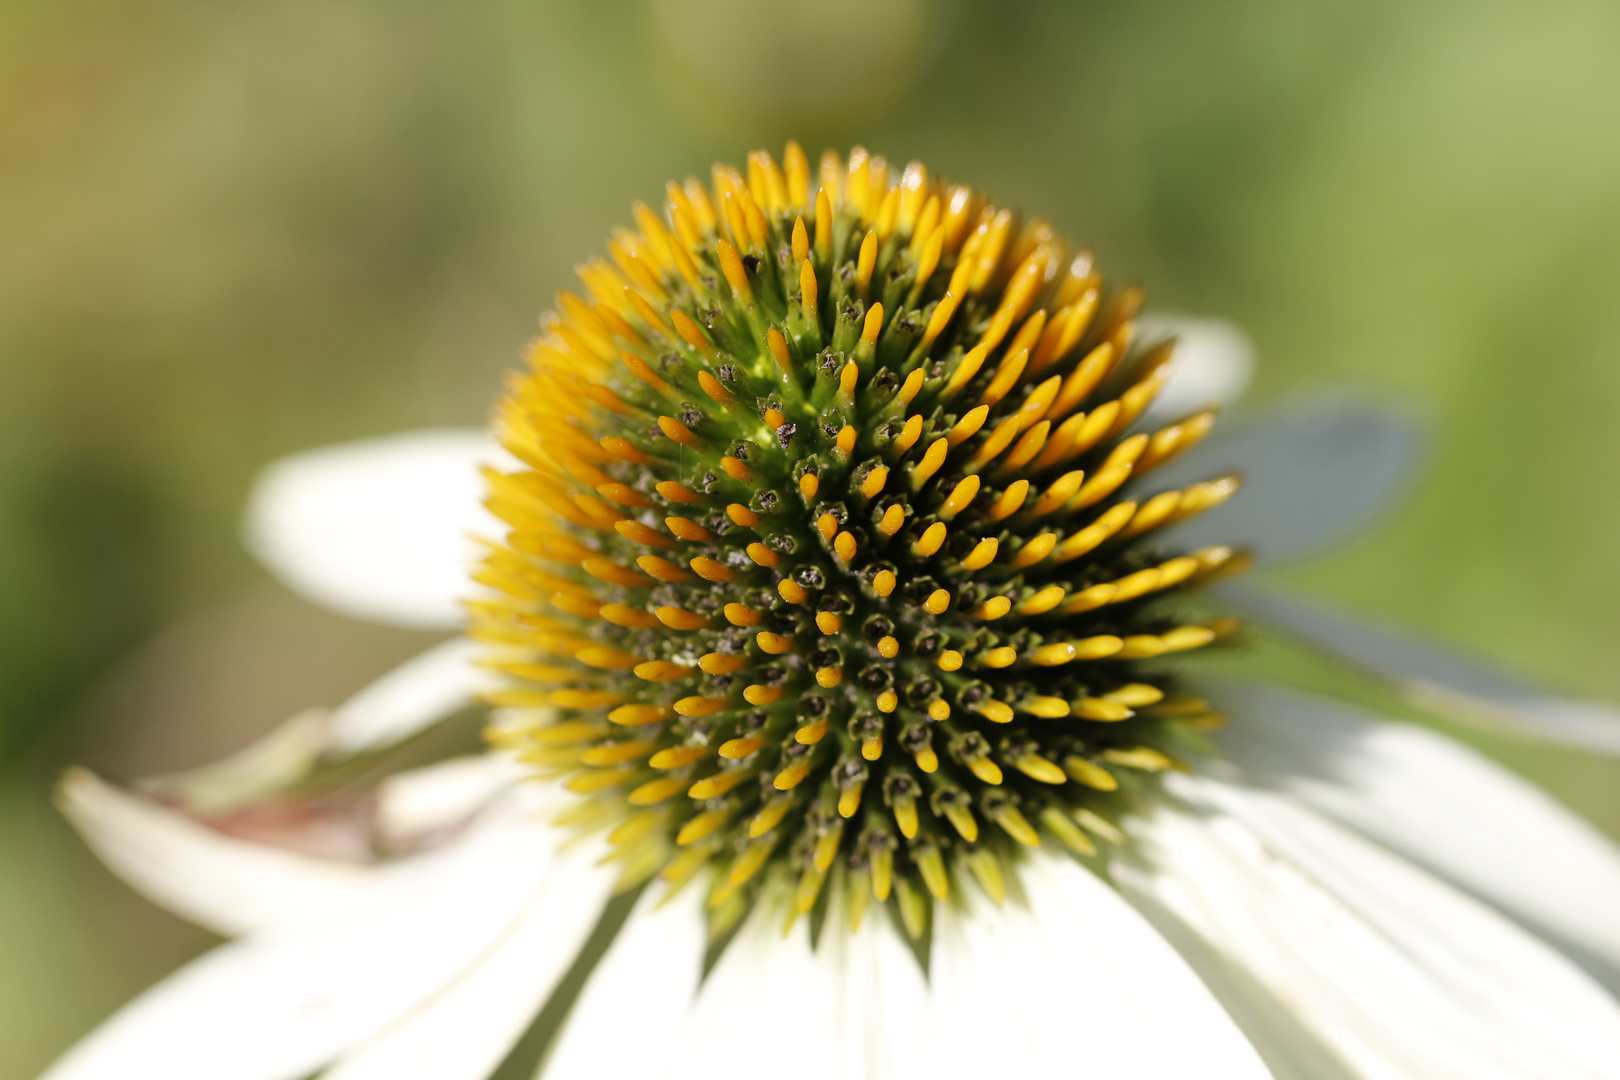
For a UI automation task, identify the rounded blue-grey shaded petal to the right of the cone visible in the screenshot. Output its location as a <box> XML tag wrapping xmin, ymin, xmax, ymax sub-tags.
<box><xmin>1149</xmin><ymin>402</ymin><xmax>1422</xmax><ymax>565</ymax></box>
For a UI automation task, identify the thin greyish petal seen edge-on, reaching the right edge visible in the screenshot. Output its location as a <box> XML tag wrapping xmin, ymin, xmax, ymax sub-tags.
<box><xmin>1220</xmin><ymin>585</ymin><xmax>1620</xmax><ymax>756</ymax></box>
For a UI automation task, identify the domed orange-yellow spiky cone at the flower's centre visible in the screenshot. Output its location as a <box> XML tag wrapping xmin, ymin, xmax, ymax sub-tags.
<box><xmin>470</xmin><ymin>144</ymin><xmax>1238</xmax><ymax>934</ymax></box>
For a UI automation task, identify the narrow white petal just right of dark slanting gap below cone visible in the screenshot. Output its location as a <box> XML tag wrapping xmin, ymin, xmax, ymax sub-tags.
<box><xmin>541</xmin><ymin>886</ymin><xmax>706</xmax><ymax>1080</ymax></box>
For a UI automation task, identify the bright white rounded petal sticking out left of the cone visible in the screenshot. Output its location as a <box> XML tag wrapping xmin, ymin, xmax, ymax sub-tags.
<box><xmin>243</xmin><ymin>431</ymin><xmax>510</xmax><ymax>627</ymax></box>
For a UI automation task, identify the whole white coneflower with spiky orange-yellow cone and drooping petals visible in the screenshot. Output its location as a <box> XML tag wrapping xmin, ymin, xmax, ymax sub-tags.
<box><xmin>49</xmin><ymin>146</ymin><xmax>1620</xmax><ymax>1080</ymax></box>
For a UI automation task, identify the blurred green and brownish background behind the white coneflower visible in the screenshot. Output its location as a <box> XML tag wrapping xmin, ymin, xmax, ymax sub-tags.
<box><xmin>0</xmin><ymin>0</ymin><xmax>1620</xmax><ymax>1077</ymax></box>
